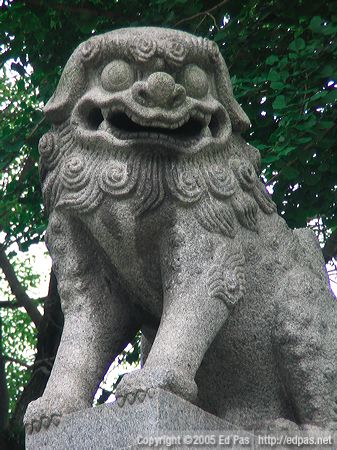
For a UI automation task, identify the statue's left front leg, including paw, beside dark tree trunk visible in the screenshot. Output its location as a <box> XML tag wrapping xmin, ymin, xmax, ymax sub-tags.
<box><xmin>24</xmin><ymin>212</ymin><xmax>138</xmax><ymax>433</ymax></box>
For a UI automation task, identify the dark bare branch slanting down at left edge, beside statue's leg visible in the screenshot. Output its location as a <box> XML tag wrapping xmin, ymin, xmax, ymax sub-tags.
<box><xmin>0</xmin><ymin>247</ymin><xmax>43</xmax><ymax>328</ymax></box>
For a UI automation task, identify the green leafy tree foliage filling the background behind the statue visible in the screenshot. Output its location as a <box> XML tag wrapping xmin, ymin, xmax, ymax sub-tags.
<box><xmin>0</xmin><ymin>0</ymin><xmax>337</xmax><ymax>448</ymax></box>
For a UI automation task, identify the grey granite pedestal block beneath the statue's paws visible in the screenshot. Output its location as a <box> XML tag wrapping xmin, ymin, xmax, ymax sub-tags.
<box><xmin>26</xmin><ymin>389</ymin><xmax>247</xmax><ymax>450</ymax></box>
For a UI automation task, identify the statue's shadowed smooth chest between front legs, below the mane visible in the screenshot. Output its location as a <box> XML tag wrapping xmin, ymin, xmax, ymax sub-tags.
<box><xmin>82</xmin><ymin>197</ymin><xmax>171</xmax><ymax>297</ymax></box>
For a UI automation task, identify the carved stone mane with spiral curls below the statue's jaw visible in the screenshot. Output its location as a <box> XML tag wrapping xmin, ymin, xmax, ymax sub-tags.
<box><xmin>39</xmin><ymin>125</ymin><xmax>275</xmax><ymax>237</ymax></box>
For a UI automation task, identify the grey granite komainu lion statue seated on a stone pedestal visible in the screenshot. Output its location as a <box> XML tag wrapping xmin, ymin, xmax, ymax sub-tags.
<box><xmin>25</xmin><ymin>27</ymin><xmax>337</xmax><ymax>433</ymax></box>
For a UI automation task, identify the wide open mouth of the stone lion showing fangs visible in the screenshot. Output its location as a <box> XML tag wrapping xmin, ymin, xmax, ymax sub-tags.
<box><xmin>81</xmin><ymin>108</ymin><xmax>221</xmax><ymax>143</ymax></box>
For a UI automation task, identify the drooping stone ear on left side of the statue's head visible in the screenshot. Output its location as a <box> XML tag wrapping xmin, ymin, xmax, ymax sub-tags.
<box><xmin>44</xmin><ymin>51</ymin><xmax>87</xmax><ymax>123</ymax></box>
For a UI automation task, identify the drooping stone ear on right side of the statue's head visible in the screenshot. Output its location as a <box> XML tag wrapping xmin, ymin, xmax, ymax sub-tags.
<box><xmin>215</xmin><ymin>54</ymin><xmax>250</xmax><ymax>132</ymax></box>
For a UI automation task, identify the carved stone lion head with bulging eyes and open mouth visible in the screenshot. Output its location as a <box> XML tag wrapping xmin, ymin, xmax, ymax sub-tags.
<box><xmin>45</xmin><ymin>27</ymin><xmax>249</xmax><ymax>154</ymax></box>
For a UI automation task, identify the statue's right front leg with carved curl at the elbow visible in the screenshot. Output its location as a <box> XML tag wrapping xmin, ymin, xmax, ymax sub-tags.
<box><xmin>116</xmin><ymin>225</ymin><xmax>244</xmax><ymax>403</ymax></box>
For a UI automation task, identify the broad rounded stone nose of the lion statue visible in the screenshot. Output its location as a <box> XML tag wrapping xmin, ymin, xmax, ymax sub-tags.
<box><xmin>133</xmin><ymin>72</ymin><xmax>186</xmax><ymax>108</ymax></box>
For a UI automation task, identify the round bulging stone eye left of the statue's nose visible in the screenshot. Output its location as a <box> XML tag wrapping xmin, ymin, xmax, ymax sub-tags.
<box><xmin>101</xmin><ymin>59</ymin><xmax>134</xmax><ymax>92</ymax></box>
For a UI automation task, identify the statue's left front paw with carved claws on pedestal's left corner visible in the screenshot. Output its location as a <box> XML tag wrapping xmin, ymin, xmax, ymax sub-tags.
<box><xmin>23</xmin><ymin>396</ymin><xmax>88</xmax><ymax>434</ymax></box>
